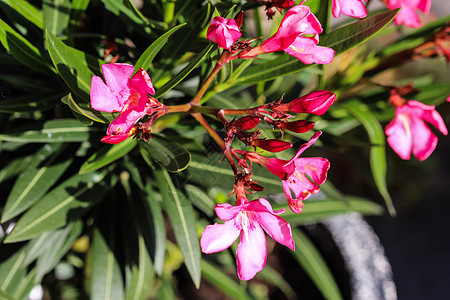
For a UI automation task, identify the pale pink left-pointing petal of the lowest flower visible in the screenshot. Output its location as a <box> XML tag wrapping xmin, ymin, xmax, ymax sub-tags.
<box><xmin>200</xmin><ymin>220</ymin><xmax>241</xmax><ymax>254</ymax></box>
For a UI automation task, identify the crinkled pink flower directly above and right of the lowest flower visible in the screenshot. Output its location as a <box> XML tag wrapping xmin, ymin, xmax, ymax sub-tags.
<box><xmin>247</xmin><ymin>131</ymin><xmax>330</xmax><ymax>214</ymax></box>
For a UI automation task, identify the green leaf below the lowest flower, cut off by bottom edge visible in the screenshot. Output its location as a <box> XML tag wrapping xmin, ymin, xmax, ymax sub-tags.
<box><xmin>202</xmin><ymin>259</ymin><xmax>252</xmax><ymax>299</ymax></box>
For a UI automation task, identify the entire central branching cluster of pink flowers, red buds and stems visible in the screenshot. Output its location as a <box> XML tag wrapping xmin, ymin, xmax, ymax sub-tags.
<box><xmin>91</xmin><ymin>5</ymin><xmax>336</xmax><ymax>280</ymax></box>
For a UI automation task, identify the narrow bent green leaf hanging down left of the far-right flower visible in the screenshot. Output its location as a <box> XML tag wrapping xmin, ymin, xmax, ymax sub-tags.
<box><xmin>344</xmin><ymin>102</ymin><xmax>396</xmax><ymax>216</ymax></box>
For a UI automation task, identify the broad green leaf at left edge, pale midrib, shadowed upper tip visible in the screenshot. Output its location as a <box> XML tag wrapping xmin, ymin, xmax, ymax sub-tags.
<box><xmin>2</xmin><ymin>144</ymin><xmax>73</xmax><ymax>222</ymax></box>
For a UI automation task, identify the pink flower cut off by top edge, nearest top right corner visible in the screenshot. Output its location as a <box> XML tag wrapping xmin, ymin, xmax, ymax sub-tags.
<box><xmin>385</xmin><ymin>0</ymin><xmax>431</xmax><ymax>28</ymax></box>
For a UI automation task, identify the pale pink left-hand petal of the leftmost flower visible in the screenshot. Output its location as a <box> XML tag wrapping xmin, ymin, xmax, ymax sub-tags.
<box><xmin>90</xmin><ymin>76</ymin><xmax>123</xmax><ymax>113</ymax></box>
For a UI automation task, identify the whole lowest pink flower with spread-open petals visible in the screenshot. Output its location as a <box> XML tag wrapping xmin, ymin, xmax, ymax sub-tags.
<box><xmin>200</xmin><ymin>198</ymin><xmax>295</xmax><ymax>280</ymax></box>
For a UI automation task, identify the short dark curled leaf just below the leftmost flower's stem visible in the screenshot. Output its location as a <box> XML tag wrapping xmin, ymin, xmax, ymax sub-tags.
<box><xmin>139</xmin><ymin>136</ymin><xmax>191</xmax><ymax>172</ymax></box>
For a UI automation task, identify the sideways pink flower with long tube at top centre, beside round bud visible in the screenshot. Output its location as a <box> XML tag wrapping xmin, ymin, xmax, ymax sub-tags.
<box><xmin>240</xmin><ymin>1</ymin><xmax>334</xmax><ymax>64</ymax></box>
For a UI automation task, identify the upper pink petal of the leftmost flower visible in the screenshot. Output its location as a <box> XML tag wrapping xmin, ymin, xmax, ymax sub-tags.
<box><xmin>102</xmin><ymin>63</ymin><xmax>134</xmax><ymax>93</ymax></box>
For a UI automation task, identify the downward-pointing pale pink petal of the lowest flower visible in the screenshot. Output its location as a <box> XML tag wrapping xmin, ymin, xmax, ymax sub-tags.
<box><xmin>236</xmin><ymin>222</ymin><xmax>267</xmax><ymax>280</ymax></box>
